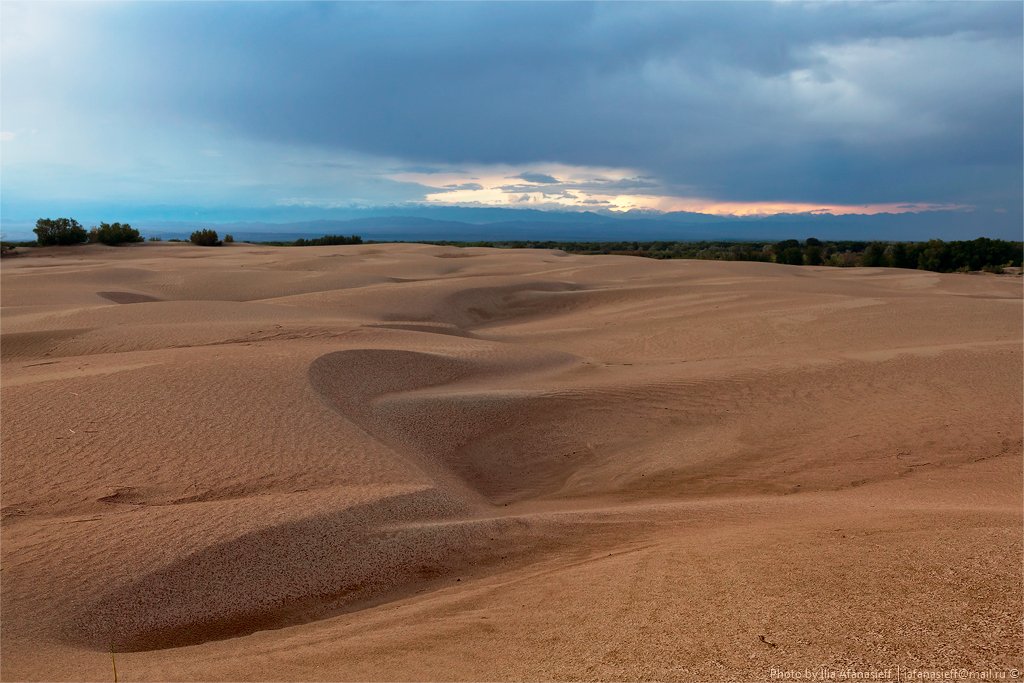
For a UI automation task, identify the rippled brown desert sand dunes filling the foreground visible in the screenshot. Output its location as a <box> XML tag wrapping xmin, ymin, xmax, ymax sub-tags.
<box><xmin>0</xmin><ymin>244</ymin><xmax>1024</xmax><ymax>681</ymax></box>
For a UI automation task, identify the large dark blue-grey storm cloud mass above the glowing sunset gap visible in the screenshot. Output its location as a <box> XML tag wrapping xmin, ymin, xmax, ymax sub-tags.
<box><xmin>4</xmin><ymin>2</ymin><xmax>1024</xmax><ymax>215</ymax></box>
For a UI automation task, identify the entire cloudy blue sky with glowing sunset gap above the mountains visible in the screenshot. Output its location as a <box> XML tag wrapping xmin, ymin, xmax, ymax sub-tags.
<box><xmin>0</xmin><ymin>0</ymin><xmax>1024</xmax><ymax>239</ymax></box>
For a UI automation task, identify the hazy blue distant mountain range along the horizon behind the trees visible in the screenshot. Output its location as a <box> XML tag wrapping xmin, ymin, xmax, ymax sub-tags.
<box><xmin>2</xmin><ymin>205</ymin><xmax>1022</xmax><ymax>242</ymax></box>
